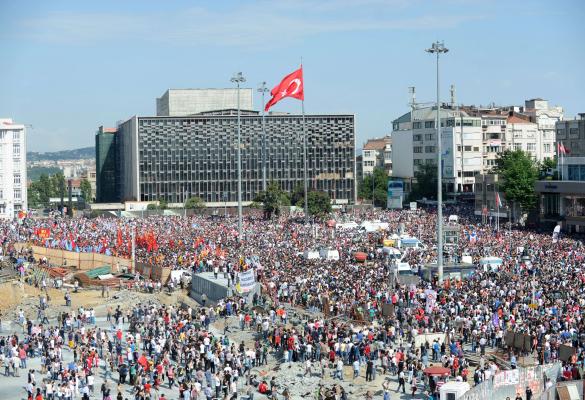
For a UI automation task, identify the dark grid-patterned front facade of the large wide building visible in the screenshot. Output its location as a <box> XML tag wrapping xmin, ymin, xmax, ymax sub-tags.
<box><xmin>129</xmin><ymin>115</ymin><xmax>355</xmax><ymax>203</ymax></box>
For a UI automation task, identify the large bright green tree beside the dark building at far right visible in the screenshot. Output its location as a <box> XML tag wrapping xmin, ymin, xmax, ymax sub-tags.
<box><xmin>493</xmin><ymin>150</ymin><xmax>538</xmax><ymax>211</ymax></box>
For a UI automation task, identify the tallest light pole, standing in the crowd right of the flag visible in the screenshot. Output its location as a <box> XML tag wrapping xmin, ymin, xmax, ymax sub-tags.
<box><xmin>425</xmin><ymin>41</ymin><xmax>448</xmax><ymax>283</ymax></box>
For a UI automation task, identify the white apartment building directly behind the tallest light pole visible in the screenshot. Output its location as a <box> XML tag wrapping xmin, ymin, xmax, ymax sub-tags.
<box><xmin>392</xmin><ymin>105</ymin><xmax>483</xmax><ymax>193</ymax></box>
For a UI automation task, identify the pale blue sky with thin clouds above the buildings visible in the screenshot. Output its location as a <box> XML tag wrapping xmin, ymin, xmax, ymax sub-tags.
<box><xmin>0</xmin><ymin>0</ymin><xmax>585</xmax><ymax>152</ymax></box>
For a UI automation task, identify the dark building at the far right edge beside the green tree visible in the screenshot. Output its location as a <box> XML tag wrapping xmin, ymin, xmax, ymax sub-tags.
<box><xmin>536</xmin><ymin>113</ymin><xmax>585</xmax><ymax>233</ymax></box>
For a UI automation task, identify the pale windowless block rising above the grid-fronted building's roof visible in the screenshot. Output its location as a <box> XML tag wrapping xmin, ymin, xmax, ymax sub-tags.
<box><xmin>156</xmin><ymin>88</ymin><xmax>254</xmax><ymax>117</ymax></box>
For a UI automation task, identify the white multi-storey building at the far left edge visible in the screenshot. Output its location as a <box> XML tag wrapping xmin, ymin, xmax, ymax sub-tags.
<box><xmin>0</xmin><ymin>118</ymin><xmax>27</xmax><ymax>219</ymax></box>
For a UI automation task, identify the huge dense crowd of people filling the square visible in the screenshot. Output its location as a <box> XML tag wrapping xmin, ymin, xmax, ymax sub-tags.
<box><xmin>0</xmin><ymin>207</ymin><xmax>585</xmax><ymax>399</ymax></box>
